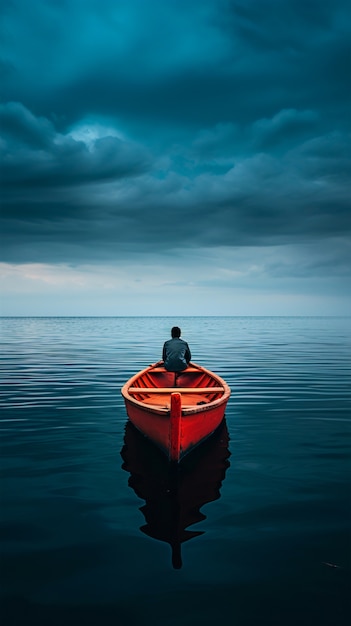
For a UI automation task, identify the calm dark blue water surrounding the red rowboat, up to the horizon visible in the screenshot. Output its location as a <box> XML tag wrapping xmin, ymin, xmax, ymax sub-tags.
<box><xmin>0</xmin><ymin>317</ymin><xmax>351</xmax><ymax>626</ymax></box>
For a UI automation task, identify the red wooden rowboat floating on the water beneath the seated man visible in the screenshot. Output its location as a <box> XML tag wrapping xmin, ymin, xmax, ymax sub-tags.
<box><xmin>122</xmin><ymin>362</ymin><xmax>230</xmax><ymax>462</ymax></box>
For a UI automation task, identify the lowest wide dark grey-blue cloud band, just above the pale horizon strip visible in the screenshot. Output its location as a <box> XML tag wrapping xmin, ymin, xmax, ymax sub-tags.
<box><xmin>4</xmin><ymin>125</ymin><xmax>351</xmax><ymax>261</ymax></box>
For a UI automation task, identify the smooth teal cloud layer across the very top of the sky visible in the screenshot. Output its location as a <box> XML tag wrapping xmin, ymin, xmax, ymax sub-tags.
<box><xmin>3</xmin><ymin>0</ymin><xmax>351</xmax><ymax>134</ymax></box>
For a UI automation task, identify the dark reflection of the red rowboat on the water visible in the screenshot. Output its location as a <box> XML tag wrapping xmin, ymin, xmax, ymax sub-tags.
<box><xmin>121</xmin><ymin>419</ymin><xmax>230</xmax><ymax>569</ymax></box>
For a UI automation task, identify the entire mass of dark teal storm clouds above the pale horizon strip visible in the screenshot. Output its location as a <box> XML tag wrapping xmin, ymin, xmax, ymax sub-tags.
<box><xmin>0</xmin><ymin>0</ymin><xmax>351</xmax><ymax>271</ymax></box>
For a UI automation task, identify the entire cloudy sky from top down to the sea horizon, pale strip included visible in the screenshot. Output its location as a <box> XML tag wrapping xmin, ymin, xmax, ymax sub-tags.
<box><xmin>0</xmin><ymin>0</ymin><xmax>351</xmax><ymax>316</ymax></box>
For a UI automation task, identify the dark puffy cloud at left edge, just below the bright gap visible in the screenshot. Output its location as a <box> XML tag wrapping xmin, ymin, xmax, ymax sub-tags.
<box><xmin>0</xmin><ymin>103</ymin><xmax>151</xmax><ymax>188</ymax></box>
